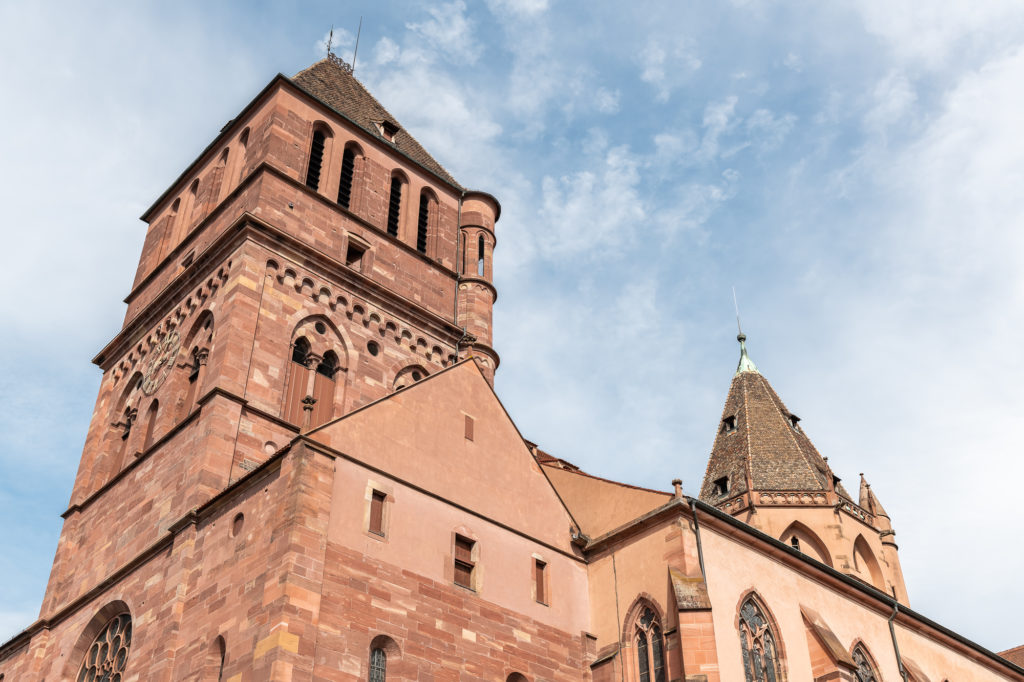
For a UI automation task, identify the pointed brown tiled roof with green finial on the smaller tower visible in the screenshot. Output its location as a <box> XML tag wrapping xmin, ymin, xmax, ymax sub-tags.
<box><xmin>700</xmin><ymin>334</ymin><xmax>850</xmax><ymax>504</ymax></box>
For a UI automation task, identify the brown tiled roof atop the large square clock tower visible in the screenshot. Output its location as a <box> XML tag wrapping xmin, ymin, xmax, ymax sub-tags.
<box><xmin>291</xmin><ymin>58</ymin><xmax>462</xmax><ymax>189</ymax></box>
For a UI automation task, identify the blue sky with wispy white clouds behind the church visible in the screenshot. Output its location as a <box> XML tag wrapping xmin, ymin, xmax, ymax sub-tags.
<box><xmin>0</xmin><ymin>0</ymin><xmax>1024</xmax><ymax>650</ymax></box>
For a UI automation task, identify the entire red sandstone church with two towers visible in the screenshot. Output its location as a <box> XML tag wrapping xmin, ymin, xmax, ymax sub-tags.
<box><xmin>0</xmin><ymin>54</ymin><xmax>1024</xmax><ymax>682</ymax></box>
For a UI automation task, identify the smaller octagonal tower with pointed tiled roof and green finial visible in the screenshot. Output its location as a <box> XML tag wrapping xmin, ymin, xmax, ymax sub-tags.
<box><xmin>700</xmin><ymin>334</ymin><xmax>908</xmax><ymax>604</ymax></box>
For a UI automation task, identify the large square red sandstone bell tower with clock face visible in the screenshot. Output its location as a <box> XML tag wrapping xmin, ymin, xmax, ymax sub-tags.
<box><xmin>40</xmin><ymin>55</ymin><xmax>501</xmax><ymax>620</ymax></box>
